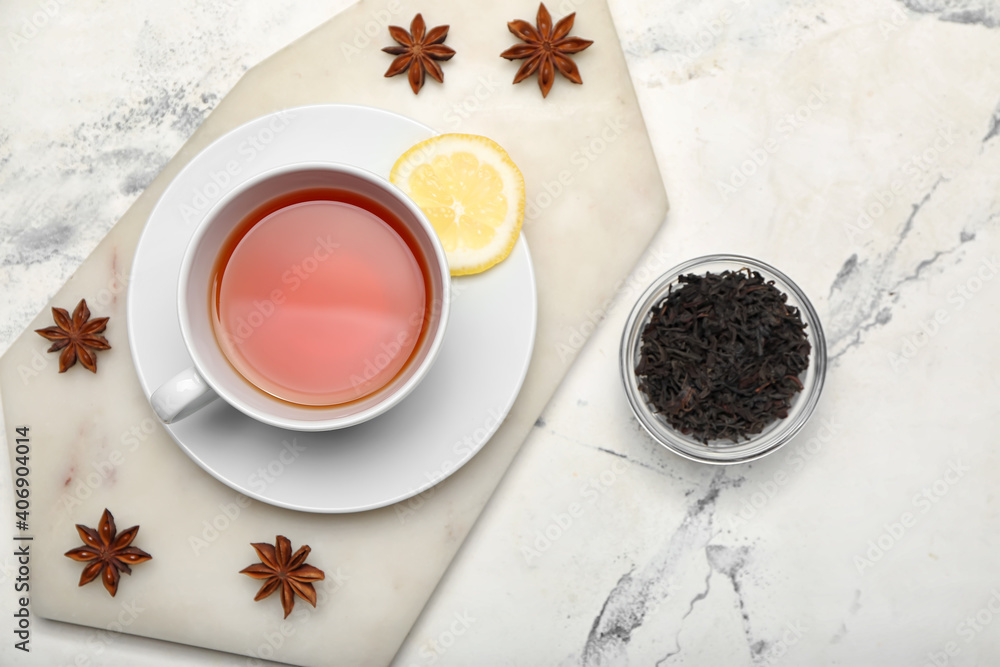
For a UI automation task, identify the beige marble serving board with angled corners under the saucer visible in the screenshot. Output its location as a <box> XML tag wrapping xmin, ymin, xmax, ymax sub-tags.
<box><xmin>0</xmin><ymin>0</ymin><xmax>667</xmax><ymax>665</ymax></box>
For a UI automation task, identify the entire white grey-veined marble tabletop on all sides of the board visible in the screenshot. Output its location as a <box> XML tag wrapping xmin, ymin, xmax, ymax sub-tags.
<box><xmin>0</xmin><ymin>0</ymin><xmax>1000</xmax><ymax>665</ymax></box>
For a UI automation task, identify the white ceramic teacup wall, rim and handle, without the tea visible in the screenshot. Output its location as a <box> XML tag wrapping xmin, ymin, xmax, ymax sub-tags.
<box><xmin>150</xmin><ymin>162</ymin><xmax>451</xmax><ymax>431</ymax></box>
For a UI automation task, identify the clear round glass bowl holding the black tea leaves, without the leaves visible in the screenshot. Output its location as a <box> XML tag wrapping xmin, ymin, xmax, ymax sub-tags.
<box><xmin>620</xmin><ymin>255</ymin><xmax>826</xmax><ymax>465</ymax></box>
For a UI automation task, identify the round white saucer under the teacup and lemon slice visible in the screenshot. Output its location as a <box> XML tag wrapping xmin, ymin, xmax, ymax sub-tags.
<box><xmin>128</xmin><ymin>105</ymin><xmax>536</xmax><ymax>512</ymax></box>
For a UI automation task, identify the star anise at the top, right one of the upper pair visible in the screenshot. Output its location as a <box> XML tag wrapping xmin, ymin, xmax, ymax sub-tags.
<box><xmin>500</xmin><ymin>3</ymin><xmax>594</xmax><ymax>97</ymax></box>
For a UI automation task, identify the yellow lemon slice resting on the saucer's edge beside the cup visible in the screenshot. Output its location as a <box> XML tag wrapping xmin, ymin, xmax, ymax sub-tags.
<box><xmin>389</xmin><ymin>134</ymin><xmax>524</xmax><ymax>276</ymax></box>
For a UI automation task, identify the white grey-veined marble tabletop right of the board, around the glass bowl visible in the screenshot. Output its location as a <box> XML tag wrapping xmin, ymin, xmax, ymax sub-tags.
<box><xmin>396</xmin><ymin>0</ymin><xmax>1000</xmax><ymax>667</ymax></box>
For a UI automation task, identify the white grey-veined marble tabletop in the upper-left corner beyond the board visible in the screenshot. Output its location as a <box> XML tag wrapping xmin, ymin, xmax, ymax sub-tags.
<box><xmin>0</xmin><ymin>0</ymin><xmax>350</xmax><ymax>353</ymax></box>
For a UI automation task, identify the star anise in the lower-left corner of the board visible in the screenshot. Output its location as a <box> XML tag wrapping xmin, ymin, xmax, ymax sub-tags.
<box><xmin>66</xmin><ymin>509</ymin><xmax>152</xmax><ymax>597</ymax></box>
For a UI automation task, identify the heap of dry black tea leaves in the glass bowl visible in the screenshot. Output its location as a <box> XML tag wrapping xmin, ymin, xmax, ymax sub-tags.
<box><xmin>635</xmin><ymin>269</ymin><xmax>810</xmax><ymax>444</ymax></box>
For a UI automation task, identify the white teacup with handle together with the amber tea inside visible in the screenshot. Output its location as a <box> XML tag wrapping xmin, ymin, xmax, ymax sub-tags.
<box><xmin>150</xmin><ymin>162</ymin><xmax>451</xmax><ymax>431</ymax></box>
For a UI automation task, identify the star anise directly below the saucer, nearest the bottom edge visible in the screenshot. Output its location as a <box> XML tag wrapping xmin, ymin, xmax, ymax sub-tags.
<box><xmin>240</xmin><ymin>536</ymin><xmax>326</xmax><ymax>618</ymax></box>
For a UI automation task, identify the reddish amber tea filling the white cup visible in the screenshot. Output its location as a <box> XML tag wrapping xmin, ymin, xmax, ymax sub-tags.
<box><xmin>210</xmin><ymin>188</ymin><xmax>432</xmax><ymax>406</ymax></box>
